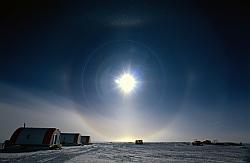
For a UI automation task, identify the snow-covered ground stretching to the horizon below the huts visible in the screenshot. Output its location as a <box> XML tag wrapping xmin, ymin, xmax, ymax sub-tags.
<box><xmin>0</xmin><ymin>143</ymin><xmax>250</xmax><ymax>163</ymax></box>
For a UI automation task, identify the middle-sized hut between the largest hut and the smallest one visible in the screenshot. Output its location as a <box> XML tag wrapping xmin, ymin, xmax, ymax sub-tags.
<box><xmin>60</xmin><ymin>133</ymin><xmax>81</xmax><ymax>146</ymax></box>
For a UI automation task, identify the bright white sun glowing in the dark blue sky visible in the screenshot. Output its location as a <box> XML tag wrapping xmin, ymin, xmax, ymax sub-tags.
<box><xmin>115</xmin><ymin>73</ymin><xmax>136</xmax><ymax>94</ymax></box>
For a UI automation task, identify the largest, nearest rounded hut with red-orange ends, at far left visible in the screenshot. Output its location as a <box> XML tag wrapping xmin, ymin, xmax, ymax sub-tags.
<box><xmin>3</xmin><ymin>127</ymin><xmax>61</xmax><ymax>152</ymax></box>
